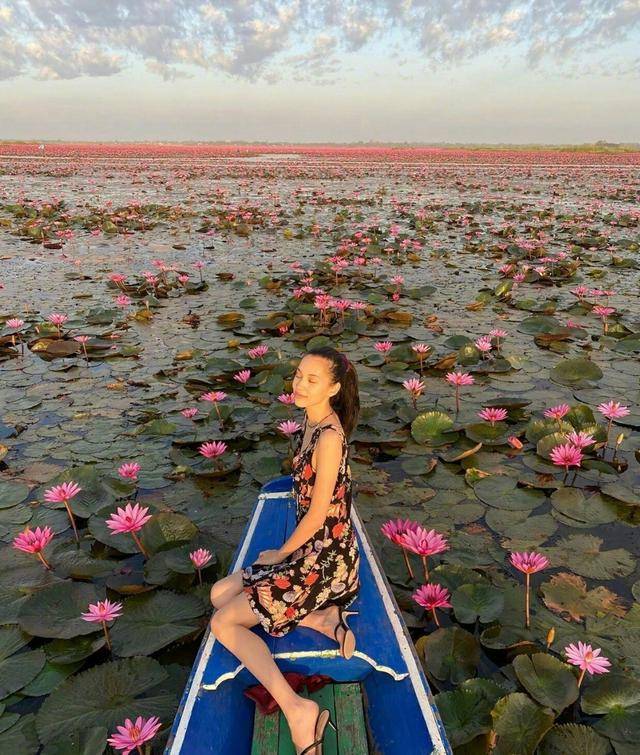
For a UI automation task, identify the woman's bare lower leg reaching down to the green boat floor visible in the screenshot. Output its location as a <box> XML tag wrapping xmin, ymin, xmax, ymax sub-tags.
<box><xmin>211</xmin><ymin>593</ymin><xmax>320</xmax><ymax>753</ymax></box>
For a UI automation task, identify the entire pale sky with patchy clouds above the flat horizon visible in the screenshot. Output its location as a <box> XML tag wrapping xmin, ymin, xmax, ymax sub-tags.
<box><xmin>0</xmin><ymin>0</ymin><xmax>640</xmax><ymax>144</ymax></box>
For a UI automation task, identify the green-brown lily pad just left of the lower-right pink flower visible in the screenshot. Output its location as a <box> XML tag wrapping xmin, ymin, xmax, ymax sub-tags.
<box><xmin>513</xmin><ymin>653</ymin><xmax>578</xmax><ymax>713</ymax></box>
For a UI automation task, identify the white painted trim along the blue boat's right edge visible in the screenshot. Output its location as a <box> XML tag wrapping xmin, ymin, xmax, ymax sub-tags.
<box><xmin>351</xmin><ymin>502</ymin><xmax>448</xmax><ymax>755</ymax></box>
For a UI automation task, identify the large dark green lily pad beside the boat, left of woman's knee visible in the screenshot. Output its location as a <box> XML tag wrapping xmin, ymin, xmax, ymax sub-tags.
<box><xmin>111</xmin><ymin>590</ymin><xmax>205</xmax><ymax>657</ymax></box>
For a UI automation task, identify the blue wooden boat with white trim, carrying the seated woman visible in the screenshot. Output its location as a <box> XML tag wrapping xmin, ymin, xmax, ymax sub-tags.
<box><xmin>165</xmin><ymin>476</ymin><xmax>451</xmax><ymax>755</ymax></box>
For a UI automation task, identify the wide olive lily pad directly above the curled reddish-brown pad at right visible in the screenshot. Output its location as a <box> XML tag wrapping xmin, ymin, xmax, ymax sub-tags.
<box><xmin>544</xmin><ymin>534</ymin><xmax>636</xmax><ymax>579</ymax></box>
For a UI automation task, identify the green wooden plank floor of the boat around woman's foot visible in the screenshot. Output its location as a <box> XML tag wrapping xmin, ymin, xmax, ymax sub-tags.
<box><xmin>251</xmin><ymin>682</ymin><xmax>369</xmax><ymax>755</ymax></box>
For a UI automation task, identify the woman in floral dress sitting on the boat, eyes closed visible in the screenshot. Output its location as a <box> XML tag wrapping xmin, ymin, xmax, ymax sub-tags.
<box><xmin>211</xmin><ymin>347</ymin><xmax>360</xmax><ymax>755</ymax></box>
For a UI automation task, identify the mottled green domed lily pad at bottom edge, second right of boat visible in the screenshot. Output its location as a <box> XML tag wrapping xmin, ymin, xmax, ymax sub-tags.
<box><xmin>491</xmin><ymin>692</ymin><xmax>555</xmax><ymax>755</ymax></box>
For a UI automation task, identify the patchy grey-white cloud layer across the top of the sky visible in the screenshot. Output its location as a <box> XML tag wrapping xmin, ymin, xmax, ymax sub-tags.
<box><xmin>0</xmin><ymin>0</ymin><xmax>640</xmax><ymax>82</ymax></box>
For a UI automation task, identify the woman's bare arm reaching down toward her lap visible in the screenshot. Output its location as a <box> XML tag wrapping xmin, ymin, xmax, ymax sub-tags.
<box><xmin>279</xmin><ymin>430</ymin><xmax>342</xmax><ymax>557</ymax></box>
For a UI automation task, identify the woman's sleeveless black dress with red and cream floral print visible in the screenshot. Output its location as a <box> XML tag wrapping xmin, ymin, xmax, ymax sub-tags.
<box><xmin>241</xmin><ymin>425</ymin><xmax>360</xmax><ymax>637</ymax></box>
